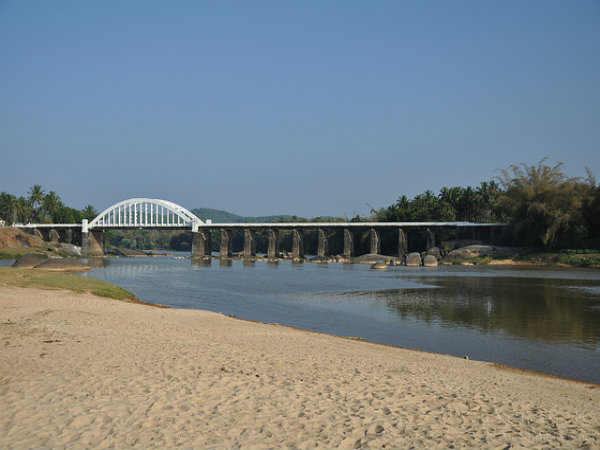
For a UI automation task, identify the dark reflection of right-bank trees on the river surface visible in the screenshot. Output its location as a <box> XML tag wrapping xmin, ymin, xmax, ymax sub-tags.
<box><xmin>352</xmin><ymin>277</ymin><xmax>600</xmax><ymax>348</ymax></box>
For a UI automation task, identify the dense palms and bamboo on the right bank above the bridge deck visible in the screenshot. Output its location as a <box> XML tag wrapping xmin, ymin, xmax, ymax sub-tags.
<box><xmin>372</xmin><ymin>158</ymin><xmax>600</xmax><ymax>249</ymax></box>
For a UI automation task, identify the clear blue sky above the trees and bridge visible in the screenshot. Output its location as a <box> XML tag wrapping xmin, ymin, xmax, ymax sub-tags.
<box><xmin>0</xmin><ymin>0</ymin><xmax>600</xmax><ymax>217</ymax></box>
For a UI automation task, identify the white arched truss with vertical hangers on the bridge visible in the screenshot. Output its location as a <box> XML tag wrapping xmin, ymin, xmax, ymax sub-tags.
<box><xmin>84</xmin><ymin>198</ymin><xmax>204</xmax><ymax>231</ymax></box>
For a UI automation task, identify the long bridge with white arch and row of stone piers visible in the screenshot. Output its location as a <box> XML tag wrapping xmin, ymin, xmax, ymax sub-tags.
<box><xmin>15</xmin><ymin>198</ymin><xmax>506</xmax><ymax>259</ymax></box>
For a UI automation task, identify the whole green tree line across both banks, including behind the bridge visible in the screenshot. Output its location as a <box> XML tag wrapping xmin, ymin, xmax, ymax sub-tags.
<box><xmin>0</xmin><ymin>158</ymin><xmax>600</xmax><ymax>251</ymax></box>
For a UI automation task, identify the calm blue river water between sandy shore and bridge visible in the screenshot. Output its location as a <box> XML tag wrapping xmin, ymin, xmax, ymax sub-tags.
<box><xmin>21</xmin><ymin>257</ymin><xmax>600</xmax><ymax>383</ymax></box>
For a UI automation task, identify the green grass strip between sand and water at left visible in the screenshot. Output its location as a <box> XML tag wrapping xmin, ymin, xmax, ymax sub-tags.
<box><xmin>0</xmin><ymin>267</ymin><xmax>144</xmax><ymax>303</ymax></box>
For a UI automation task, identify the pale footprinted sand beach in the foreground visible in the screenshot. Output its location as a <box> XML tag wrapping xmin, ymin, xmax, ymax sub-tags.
<box><xmin>0</xmin><ymin>287</ymin><xmax>600</xmax><ymax>449</ymax></box>
